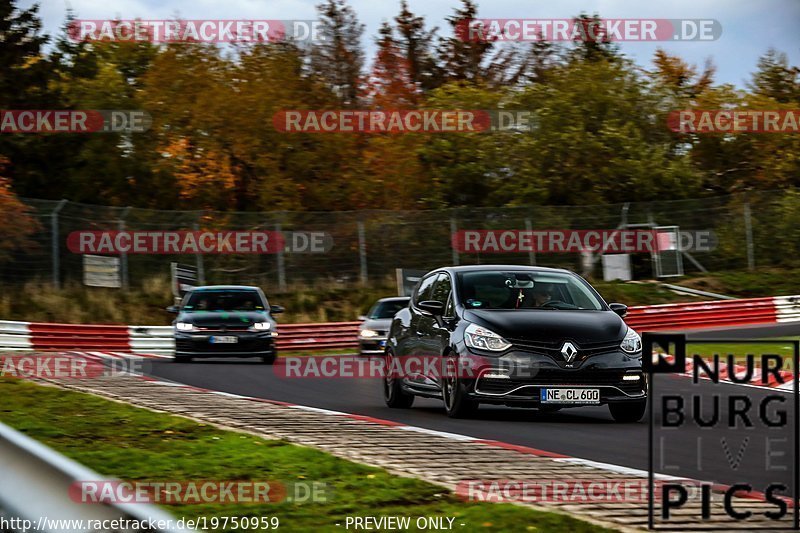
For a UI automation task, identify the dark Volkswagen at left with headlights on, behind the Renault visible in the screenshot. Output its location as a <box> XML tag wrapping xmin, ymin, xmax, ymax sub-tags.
<box><xmin>167</xmin><ymin>285</ymin><xmax>283</xmax><ymax>365</ymax></box>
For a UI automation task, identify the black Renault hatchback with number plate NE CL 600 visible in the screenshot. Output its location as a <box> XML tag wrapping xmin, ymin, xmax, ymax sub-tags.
<box><xmin>383</xmin><ymin>266</ymin><xmax>647</xmax><ymax>422</ymax></box>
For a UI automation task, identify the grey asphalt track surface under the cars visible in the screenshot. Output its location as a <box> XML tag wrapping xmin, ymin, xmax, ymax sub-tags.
<box><xmin>145</xmin><ymin>324</ymin><xmax>800</xmax><ymax>491</ymax></box>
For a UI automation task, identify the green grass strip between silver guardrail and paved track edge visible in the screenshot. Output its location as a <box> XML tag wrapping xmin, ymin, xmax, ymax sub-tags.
<box><xmin>0</xmin><ymin>378</ymin><xmax>608</xmax><ymax>532</ymax></box>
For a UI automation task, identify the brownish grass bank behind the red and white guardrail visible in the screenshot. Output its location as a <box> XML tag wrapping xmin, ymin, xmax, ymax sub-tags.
<box><xmin>0</xmin><ymin>269</ymin><xmax>800</xmax><ymax>325</ymax></box>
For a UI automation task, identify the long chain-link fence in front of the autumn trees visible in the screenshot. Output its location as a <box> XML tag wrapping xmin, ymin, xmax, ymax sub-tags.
<box><xmin>0</xmin><ymin>190</ymin><xmax>800</xmax><ymax>289</ymax></box>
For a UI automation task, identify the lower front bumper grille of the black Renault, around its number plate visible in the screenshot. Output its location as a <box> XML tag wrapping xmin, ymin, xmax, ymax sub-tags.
<box><xmin>476</xmin><ymin>369</ymin><xmax>644</xmax><ymax>394</ymax></box>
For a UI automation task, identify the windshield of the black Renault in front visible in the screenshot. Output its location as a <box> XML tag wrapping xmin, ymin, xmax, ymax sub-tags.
<box><xmin>458</xmin><ymin>270</ymin><xmax>603</xmax><ymax>311</ymax></box>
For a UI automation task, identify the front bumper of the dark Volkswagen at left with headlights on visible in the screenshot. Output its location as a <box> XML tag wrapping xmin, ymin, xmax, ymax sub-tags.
<box><xmin>175</xmin><ymin>331</ymin><xmax>275</xmax><ymax>357</ymax></box>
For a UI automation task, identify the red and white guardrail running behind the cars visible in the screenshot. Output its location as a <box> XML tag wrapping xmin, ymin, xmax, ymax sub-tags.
<box><xmin>0</xmin><ymin>295</ymin><xmax>800</xmax><ymax>354</ymax></box>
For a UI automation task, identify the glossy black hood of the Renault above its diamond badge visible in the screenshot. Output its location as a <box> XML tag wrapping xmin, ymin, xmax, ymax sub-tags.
<box><xmin>464</xmin><ymin>309</ymin><xmax>627</xmax><ymax>343</ymax></box>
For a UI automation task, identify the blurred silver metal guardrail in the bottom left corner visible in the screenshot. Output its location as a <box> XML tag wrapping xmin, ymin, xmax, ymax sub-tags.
<box><xmin>0</xmin><ymin>424</ymin><xmax>188</xmax><ymax>533</ymax></box>
